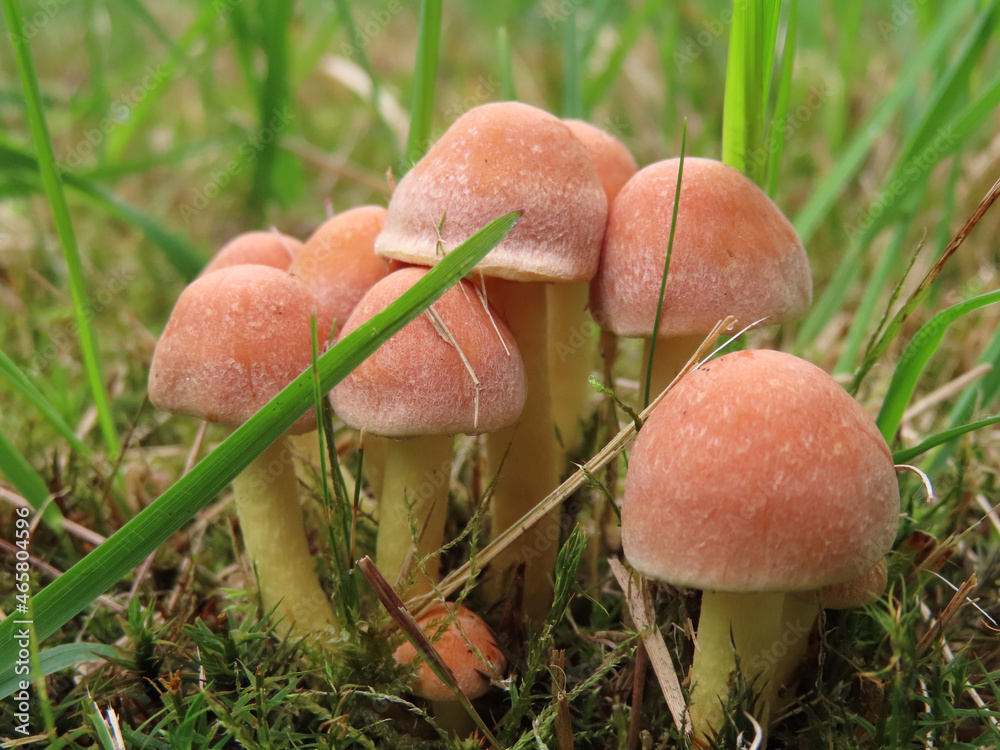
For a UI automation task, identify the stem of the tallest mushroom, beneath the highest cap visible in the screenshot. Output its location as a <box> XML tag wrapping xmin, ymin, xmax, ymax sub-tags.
<box><xmin>486</xmin><ymin>279</ymin><xmax>559</xmax><ymax>623</ymax></box>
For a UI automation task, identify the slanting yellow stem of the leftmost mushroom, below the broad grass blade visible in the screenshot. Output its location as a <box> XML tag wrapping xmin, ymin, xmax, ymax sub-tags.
<box><xmin>233</xmin><ymin>439</ymin><xmax>337</xmax><ymax>635</ymax></box>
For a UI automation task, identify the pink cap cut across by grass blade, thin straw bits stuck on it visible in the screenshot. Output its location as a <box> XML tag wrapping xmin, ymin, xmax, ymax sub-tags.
<box><xmin>331</xmin><ymin>267</ymin><xmax>525</xmax><ymax>437</ymax></box>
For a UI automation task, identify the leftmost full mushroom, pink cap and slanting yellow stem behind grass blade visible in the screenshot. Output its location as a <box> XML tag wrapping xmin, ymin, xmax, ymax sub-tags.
<box><xmin>149</xmin><ymin>265</ymin><xmax>336</xmax><ymax>635</ymax></box>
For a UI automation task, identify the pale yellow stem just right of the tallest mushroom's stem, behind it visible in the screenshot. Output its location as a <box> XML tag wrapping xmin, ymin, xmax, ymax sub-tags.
<box><xmin>546</xmin><ymin>282</ymin><xmax>599</xmax><ymax>458</ymax></box>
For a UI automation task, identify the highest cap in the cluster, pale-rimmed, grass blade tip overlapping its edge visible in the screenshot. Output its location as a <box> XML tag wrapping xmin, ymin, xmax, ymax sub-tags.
<box><xmin>375</xmin><ymin>102</ymin><xmax>608</xmax><ymax>281</ymax></box>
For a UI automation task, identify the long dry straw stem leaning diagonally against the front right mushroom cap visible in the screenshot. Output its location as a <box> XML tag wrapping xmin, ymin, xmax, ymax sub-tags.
<box><xmin>409</xmin><ymin>315</ymin><xmax>736</xmax><ymax>617</ymax></box>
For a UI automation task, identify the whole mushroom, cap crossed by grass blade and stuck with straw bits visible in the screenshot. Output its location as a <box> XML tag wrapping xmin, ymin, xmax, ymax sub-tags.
<box><xmin>331</xmin><ymin>267</ymin><xmax>525</xmax><ymax>597</ymax></box>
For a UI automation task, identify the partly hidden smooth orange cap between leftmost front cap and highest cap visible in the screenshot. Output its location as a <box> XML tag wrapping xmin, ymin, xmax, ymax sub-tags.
<box><xmin>288</xmin><ymin>206</ymin><xmax>391</xmax><ymax>338</ymax></box>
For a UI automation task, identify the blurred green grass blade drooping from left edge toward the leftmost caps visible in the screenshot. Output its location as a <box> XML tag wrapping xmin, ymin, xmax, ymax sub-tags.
<box><xmin>0</xmin><ymin>138</ymin><xmax>205</xmax><ymax>281</ymax></box>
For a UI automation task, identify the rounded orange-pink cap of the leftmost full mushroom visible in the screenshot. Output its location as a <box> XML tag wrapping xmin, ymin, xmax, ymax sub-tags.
<box><xmin>149</xmin><ymin>265</ymin><xmax>316</xmax><ymax>433</ymax></box>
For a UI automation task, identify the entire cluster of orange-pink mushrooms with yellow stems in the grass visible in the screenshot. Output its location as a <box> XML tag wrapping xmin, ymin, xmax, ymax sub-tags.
<box><xmin>149</xmin><ymin>102</ymin><xmax>899</xmax><ymax>741</ymax></box>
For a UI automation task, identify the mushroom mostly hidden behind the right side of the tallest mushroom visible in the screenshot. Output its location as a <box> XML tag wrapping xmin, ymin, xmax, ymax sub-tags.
<box><xmin>546</xmin><ymin>120</ymin><xmax>638</xmax><ymax>456</ymax></box>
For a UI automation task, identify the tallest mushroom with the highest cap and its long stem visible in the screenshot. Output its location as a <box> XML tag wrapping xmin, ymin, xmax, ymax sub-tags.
<box><xmin>375</xmin><ymin>102</ymin><xmax>607</xmax><ymax>622</ymax></box>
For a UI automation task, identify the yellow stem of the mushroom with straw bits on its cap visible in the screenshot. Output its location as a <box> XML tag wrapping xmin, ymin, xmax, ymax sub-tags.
<box><xmin>376</xmin><ymin>435</ymin><xmax>454</xmax><ymax>597</ymax></box>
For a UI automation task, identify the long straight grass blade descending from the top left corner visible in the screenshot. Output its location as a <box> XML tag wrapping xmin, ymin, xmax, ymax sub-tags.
<box><xmin>2</xmin><ymin>0</ymin><xmax>120</xmax><ymax>456</ymax></box>
